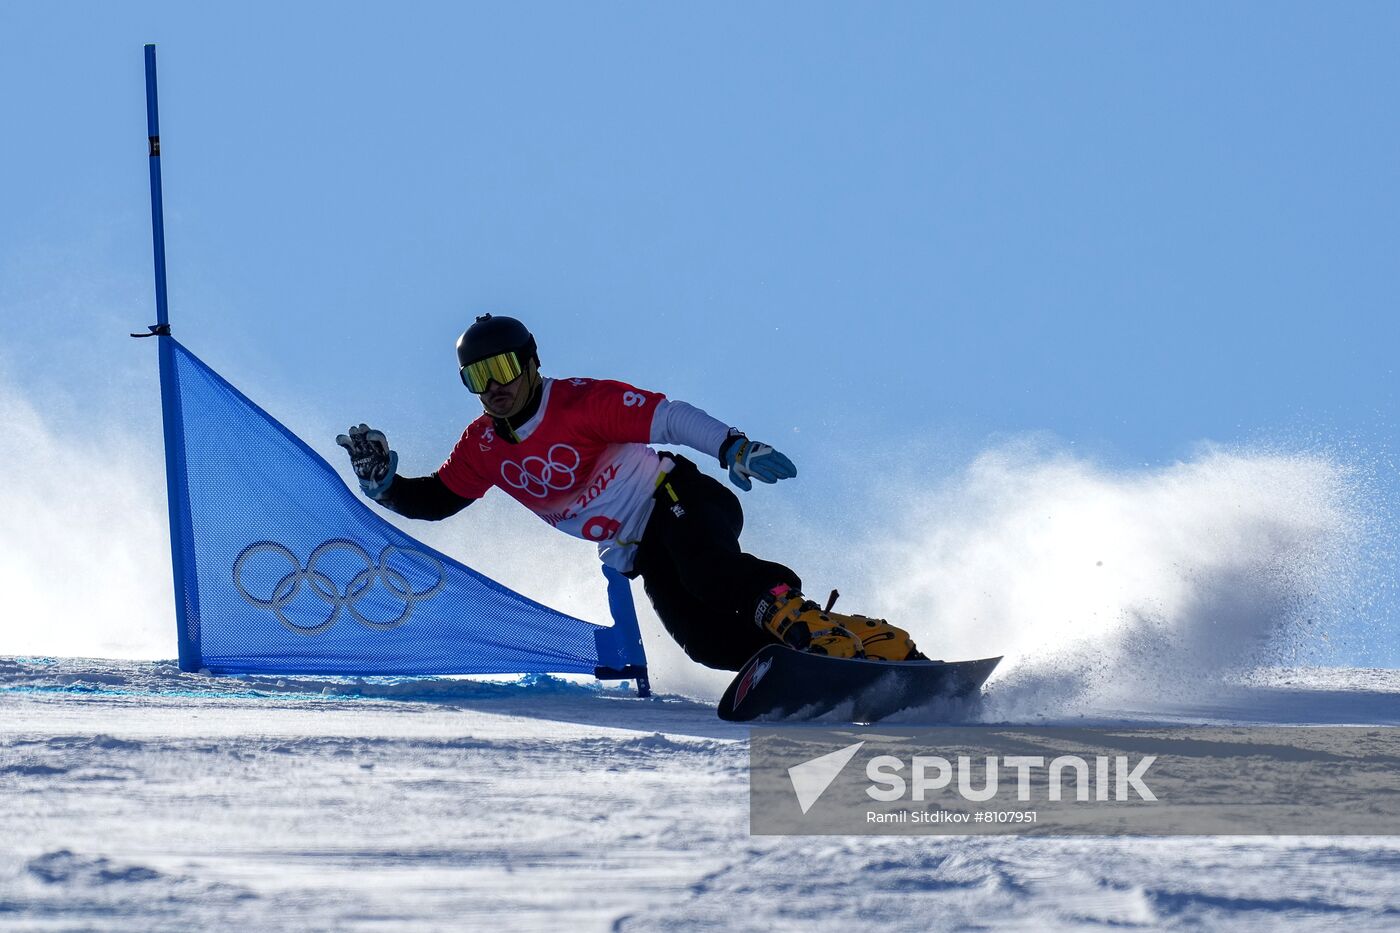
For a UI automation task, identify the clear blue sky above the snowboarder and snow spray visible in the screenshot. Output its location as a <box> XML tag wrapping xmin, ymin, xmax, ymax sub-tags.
<box><xmin>0</xmin><ymin>1</ymin><xmax>1400</xmax><ymax>661</ymax></box>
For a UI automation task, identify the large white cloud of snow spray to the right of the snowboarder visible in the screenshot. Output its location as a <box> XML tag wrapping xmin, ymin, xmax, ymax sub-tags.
<box><xmin>845</xmin><ymin>441</ymin><xmax>1369</xmax><ymax>717</ymax></box>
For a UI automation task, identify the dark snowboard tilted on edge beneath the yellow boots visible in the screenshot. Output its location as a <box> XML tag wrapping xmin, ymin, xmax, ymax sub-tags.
<box><xmin>718</xmin><ymin>644</ymin><xmax>1001</xmax><ymax>723</ymax></box>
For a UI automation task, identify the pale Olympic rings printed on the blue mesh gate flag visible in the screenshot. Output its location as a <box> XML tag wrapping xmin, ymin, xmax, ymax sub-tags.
<box><xmin>234</xmin><ymin>538</ymin><xmax>447</xmax><ymax>635</ymax></box>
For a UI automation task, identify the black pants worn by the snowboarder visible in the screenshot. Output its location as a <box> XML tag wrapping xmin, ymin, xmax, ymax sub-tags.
<box><xmin>630</xmin><ymin>454</ymin><xmax>802</xmax><ymax>671</ymax></box>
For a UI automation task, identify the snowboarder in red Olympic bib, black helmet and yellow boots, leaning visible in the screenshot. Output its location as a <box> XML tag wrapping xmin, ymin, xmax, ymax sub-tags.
<box><xmin>336</xmin><ymin>314</ymin><xmax>924</xmax><ymax>671</ymax></box>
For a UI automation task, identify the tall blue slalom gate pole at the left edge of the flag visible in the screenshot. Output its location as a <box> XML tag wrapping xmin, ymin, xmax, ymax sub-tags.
<box><xmin>144</xmin><ymin>45</ymin><xmax>202</xmax><ymax>671</ymax></box>
